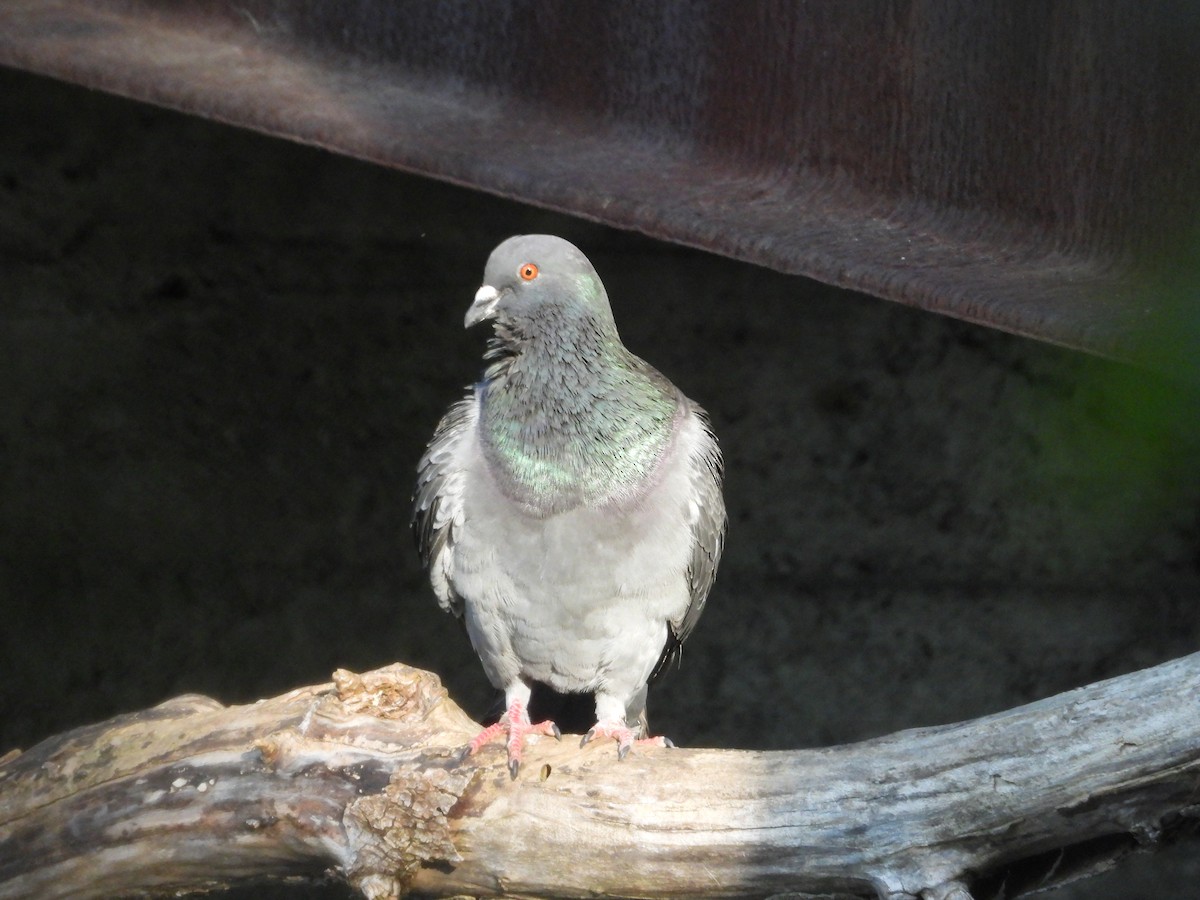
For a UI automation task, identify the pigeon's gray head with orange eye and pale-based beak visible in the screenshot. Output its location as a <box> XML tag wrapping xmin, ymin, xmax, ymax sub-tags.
<box><xmin>466</xmin><ymin>234</ymin><xmax>616</xmax><ymax>344</ymax></box>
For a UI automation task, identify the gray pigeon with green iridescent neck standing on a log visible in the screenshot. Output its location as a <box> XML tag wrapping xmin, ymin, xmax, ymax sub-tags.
<box><xmin>413</xmin><ymin>234</ymin><xmax>726</xmax><ymax>778</ymax></box>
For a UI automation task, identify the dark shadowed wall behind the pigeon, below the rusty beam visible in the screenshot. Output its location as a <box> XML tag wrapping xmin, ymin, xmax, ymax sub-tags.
<box><xmin>0</xmin><ymin>71</ymin><xmax>1200</xmax><ymax>899</ymax></box>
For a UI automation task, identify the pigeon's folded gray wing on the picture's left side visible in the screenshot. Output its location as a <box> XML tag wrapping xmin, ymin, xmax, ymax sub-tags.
<box><xmin>413</xmin><ymin>394</ymin><xmax>478</xmax><ymax>616</ymax></box>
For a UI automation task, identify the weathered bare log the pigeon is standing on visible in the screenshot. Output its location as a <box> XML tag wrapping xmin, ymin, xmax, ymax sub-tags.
<box><xmin>0</xmin><ymin>654</ymin><xmax>1200</xmax><ymax>900</ymax></box>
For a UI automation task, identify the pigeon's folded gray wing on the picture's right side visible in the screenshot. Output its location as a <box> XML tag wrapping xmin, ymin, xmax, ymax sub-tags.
<box><xmin>650</xmin><ymin>401</ymin><xmax>727</xmax><ymax>680</ymax></box>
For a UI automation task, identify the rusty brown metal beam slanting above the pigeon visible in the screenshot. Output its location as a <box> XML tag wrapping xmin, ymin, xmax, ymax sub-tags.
<box><xmin>0</xmin><ymin>0</ymin><xmax>1200</xmax><ymax>367</ymax></box>
